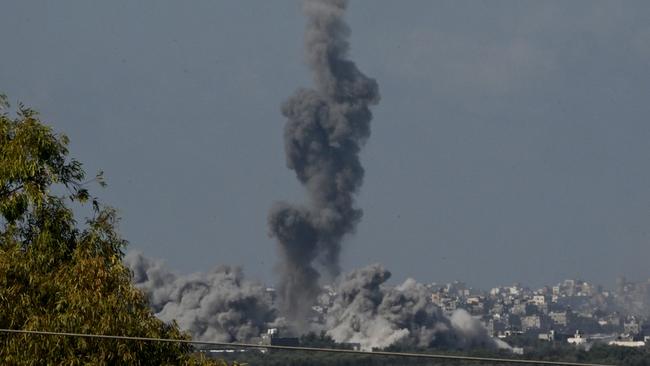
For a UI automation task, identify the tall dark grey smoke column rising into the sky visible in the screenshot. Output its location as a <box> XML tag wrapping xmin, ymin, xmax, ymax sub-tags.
<box><xmin>268</xmin><ymin>0</ymin><xmax>379</xmax><ymax>326</ymax></box>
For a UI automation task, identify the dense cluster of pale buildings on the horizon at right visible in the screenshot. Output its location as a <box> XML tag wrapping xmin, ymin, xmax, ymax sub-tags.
<box><xmin>429</xmin><ymin>278</ymin><xmax>650</xmax><ymax>347</ymax></box>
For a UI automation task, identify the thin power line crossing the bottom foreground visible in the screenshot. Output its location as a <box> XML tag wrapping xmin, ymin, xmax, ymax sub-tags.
<box><xmin>0</xmin><ymin>329</ymin><xmax>614</xmax><ymax>366</ymax></box>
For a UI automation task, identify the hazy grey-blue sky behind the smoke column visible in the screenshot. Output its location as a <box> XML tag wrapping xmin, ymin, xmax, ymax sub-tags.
<box><xmin>0</xmin><ymin>0</ymin><xmax>650</xmax><ymax>287</ymax></box>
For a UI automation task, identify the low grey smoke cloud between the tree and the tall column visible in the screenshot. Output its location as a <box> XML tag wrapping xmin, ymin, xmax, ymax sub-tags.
<box><xmin>124</xmin><ymin>252</ymin><xmax>275</xmax><ymax>342</ymax></box>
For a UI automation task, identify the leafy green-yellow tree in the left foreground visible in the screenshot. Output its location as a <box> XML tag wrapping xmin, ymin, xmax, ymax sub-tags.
<box><xmin>0</xmin><ymin>96</ymin><xmax>228</xmax><ymax>365</ymax></box>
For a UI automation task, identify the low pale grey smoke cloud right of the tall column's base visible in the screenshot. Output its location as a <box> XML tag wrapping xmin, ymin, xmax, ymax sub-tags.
<box><xmin>326</xmin><ymin>265</ymin><xmax>507</xmax><ymax>350</ymax></box>
